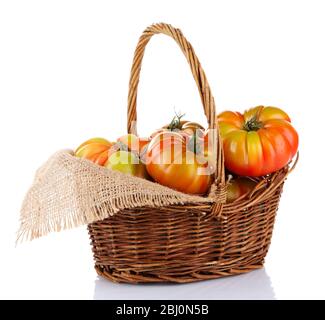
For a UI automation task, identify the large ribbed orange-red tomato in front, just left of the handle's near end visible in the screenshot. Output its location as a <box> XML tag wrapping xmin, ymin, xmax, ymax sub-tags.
<box><xmin>146</xmin><ymin>131</ymin><xmax>211</xmax><ymax>194</ymax></box>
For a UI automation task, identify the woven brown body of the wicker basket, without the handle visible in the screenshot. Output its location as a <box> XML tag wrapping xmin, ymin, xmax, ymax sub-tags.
<box><xmin>88</xmin><ymin>172</ymin><xmax>285</xmax><ymax>283</ymax></box>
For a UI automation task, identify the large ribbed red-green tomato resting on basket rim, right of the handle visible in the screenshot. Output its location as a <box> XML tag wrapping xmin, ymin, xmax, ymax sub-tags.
<box><xmin>217</xmin><ymin>106</ymin><xmax>299</xmax><ymax>177</ymax></box>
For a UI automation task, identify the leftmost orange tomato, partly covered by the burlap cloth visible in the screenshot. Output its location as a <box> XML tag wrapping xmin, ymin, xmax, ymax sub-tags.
<box><xmin>75</xmin><ymin>138</ymin><xmax>114</xmax><ymax>166</ymax></box>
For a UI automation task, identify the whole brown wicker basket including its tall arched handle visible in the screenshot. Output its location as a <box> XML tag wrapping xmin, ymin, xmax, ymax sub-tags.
<box><xmin>88</xmin><ymin>24</ymin><xmax>290</xmax><ymax>283</ymax></box>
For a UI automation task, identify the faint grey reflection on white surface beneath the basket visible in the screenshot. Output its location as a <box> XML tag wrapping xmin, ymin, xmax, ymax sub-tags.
<box><xmin>94</xmin><ymin>268</ymin><xmax>275</xmax><ymax>300</ymax></box>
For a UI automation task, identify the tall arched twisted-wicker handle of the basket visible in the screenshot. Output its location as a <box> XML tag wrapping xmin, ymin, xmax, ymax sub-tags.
<box><xmin>127</xmin><ymin>23</ymin><xmax>225</xmax><ymax>186</ymax></box>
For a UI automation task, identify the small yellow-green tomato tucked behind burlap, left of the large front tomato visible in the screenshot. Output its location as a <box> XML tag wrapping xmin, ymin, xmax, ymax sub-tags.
<box><xmin>105</xmin><ymin>150</ymin><xmax>147</xmax><ymax>178</ymax></box>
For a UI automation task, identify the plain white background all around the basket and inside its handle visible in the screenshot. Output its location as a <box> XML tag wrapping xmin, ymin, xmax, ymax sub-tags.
<box><xmin>0</xmin><ymin>0</ymin><xmax>325</xmax><ymax>299</ymax></box>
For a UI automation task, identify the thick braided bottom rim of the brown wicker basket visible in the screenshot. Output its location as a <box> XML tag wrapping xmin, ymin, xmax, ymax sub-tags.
<box><xmin>95</xmin><ymin>260</ymin><xmax>264</xmax><ymax>283</ymax></box>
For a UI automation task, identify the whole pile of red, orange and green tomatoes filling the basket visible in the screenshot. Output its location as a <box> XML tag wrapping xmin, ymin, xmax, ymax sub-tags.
<box><xmin>75</xmin><ymin>106</ymin><xmax>298</xmax><ymax>202</ymax></box>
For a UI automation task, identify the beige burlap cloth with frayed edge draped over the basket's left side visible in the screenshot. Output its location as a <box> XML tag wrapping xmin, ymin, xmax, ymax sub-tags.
<box><xmin>17</xmin><ymin>150</ymin><xmax>212</xmax><ymax>242</ymax></box>
